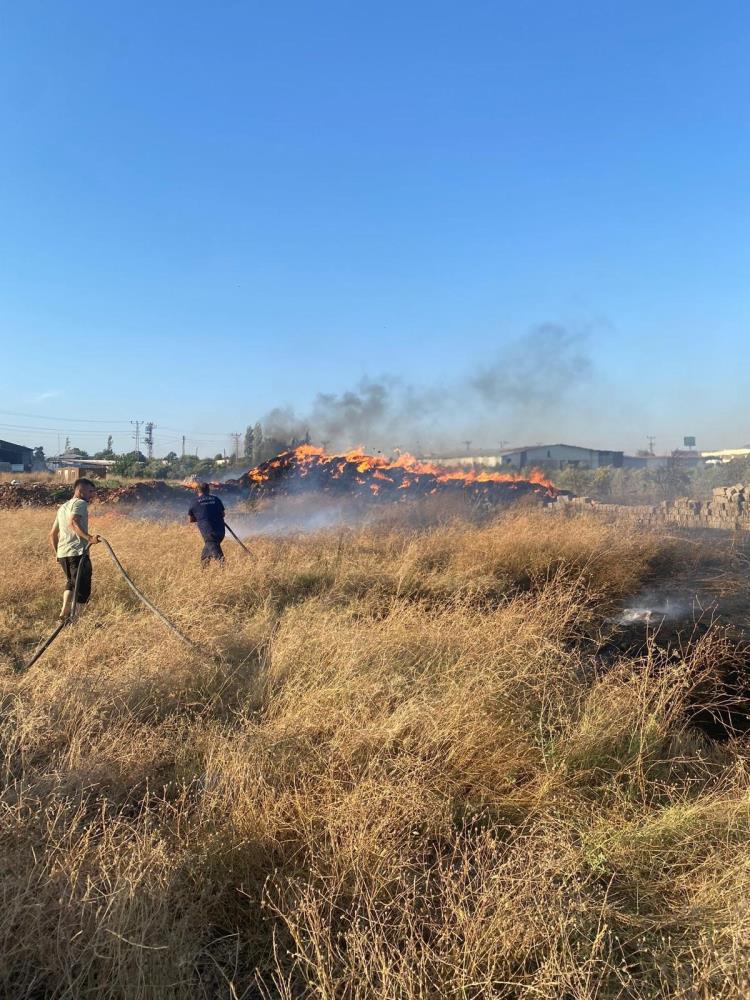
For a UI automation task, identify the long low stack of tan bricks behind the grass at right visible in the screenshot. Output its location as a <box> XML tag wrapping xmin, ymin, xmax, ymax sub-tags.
<box><xmin>547</xmin><ymin>483</ymin><xmax>750</xmax><ymax>531</ymax></box>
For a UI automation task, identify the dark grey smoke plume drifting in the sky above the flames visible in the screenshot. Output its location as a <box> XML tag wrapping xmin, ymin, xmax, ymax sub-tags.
<box><xmin>263</xmin><ymin>323</ymin><xmax>594</xmax><ymax>451</ymax></box>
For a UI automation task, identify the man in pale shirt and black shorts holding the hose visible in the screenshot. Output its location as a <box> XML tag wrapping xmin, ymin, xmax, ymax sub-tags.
<box><xmin>49</xmin><ymin>479</ymin><xmax>99</xmax><ymax>621</ymax></box>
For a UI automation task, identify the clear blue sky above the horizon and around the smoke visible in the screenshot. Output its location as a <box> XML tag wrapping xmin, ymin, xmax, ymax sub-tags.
<box><xmin>0</xmin><ymin>0</ymin><xmax>750</xmax><ymax>454</ymax></box>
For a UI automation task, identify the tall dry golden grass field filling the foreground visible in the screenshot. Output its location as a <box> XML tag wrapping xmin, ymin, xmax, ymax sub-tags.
<box><xmin>0</xmin><ymin>508</ymin><xmax>750</xmax><ymax>1000</ymax></box>
